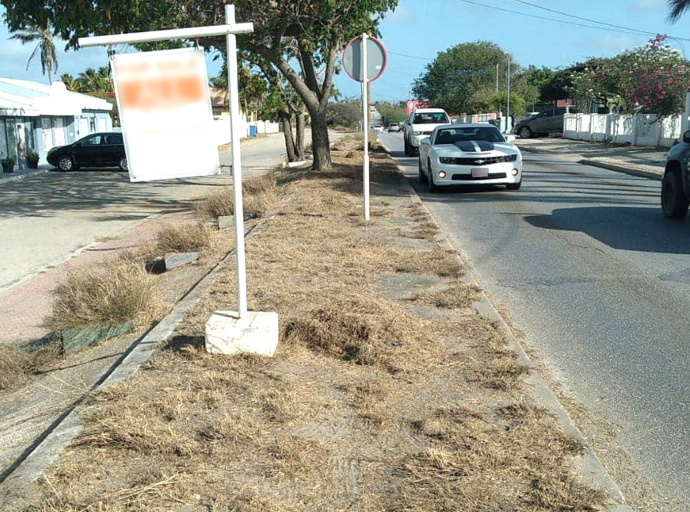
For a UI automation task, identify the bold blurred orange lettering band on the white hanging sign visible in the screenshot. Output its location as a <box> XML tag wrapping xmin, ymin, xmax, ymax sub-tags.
<box><xmin>117</xmin><ymin>75</ymin><xmax>204</xmax><ymax>110</ymax></box>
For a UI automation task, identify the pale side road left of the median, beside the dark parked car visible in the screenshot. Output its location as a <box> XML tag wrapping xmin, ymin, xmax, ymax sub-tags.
<box><xmin>0</xmin><ymin>134</ymin><xmax>285</xmax><ymax>293</ymax></box>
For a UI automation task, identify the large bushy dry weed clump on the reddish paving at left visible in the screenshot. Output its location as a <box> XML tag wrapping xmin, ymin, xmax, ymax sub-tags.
<box><xmin>46</xmin><ymin>259</ymin><xmax>157</xmax><ymax>331</ymax></box>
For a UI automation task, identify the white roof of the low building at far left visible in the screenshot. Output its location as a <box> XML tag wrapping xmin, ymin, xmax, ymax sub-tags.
<box><xmin>0</xmin><ymin>78</ymin><xmax>113</xmax><ymax>117</ymax></box>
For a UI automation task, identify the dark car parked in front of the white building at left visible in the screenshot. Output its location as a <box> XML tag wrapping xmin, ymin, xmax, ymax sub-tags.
<box><xmin>46</xmin><ymin>132</ymin><xmax>128</xmax><ymax>171</ymax></box>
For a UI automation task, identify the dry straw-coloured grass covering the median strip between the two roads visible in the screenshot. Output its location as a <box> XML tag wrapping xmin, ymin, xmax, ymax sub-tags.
<box><xmin>22</xmin><ymin>135</ymin><xmax>604</xmax><ymax>512</ymax></box>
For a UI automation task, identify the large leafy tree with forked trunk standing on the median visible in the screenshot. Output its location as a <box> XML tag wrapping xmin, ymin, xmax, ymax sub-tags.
<box><xmin>0</xmin><ymin>0</ymin><xmax>398</xmax><ymax>169</ymax></box>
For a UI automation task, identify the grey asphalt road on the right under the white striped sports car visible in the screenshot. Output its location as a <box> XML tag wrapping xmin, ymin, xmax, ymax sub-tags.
<box><xmin>380</xmin><ymin>134</ymin><xmax>690</xmax><ymax>511</ymax></box>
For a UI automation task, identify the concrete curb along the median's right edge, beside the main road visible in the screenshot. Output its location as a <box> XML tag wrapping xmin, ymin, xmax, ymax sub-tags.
<box><xmin>380</xmin><ymin>138</ymin><xmax>634</xmax><ymax>512</ymax></box>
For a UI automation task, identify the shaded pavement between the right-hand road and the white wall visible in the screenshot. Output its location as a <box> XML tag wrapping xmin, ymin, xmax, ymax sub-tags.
<box><xmin>515</xmin><ymin>137</ymin><xmax>668</xmax><ymax>180</ymax></box>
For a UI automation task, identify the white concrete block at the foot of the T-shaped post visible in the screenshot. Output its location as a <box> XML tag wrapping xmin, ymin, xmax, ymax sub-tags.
<box><xmin>206</xmin><ymin>311</ymin><xmax>278</xmax><ymax>357</ymax></box>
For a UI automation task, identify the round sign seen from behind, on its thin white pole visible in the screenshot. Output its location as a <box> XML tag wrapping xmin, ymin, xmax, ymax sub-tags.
<box><xmin>342</xmin><ymin>34</ymin><xmax>388</xmax><ymax>220</ymax></box>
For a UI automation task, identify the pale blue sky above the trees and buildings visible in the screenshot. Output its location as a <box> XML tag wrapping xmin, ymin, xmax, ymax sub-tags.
<box><xmin>0</xmin><ymin>0</ymin><xmax>690</xmax><ymax>105</ymax></box>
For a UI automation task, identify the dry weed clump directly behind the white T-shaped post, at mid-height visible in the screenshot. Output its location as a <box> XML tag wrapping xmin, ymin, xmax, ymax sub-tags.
<box><xmin>197</xmin><ymin>174</ymin><xmax>278</xmax><ymax>218</ymax></box>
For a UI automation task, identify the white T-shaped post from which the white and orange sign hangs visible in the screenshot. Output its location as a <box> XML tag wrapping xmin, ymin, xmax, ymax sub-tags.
<box><xmin>79</xmin><ymin>5</ymin><xmax>254</xmax><ymax>320</ymax></box>
